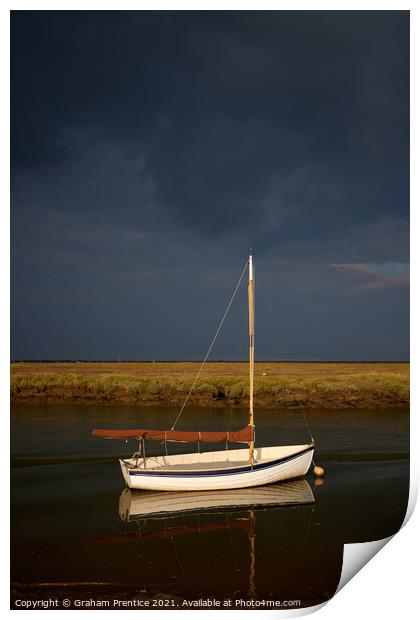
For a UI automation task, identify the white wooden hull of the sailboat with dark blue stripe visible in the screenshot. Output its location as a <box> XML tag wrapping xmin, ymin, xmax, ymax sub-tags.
<box><xmin>120</xmin><ymin>444</ymin><xmax>314</xmax><ymax>491</ymax></box>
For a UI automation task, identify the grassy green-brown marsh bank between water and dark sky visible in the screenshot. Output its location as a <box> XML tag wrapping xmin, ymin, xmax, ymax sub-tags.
<box><xmin>11</xmin><ymin>362</ymin><xmax>409</xmax><ymax>409</ymax></box>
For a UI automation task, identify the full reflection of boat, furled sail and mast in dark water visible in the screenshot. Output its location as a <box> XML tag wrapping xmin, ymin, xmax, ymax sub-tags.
<box><xmin>114</xmin><ymin>480</ymin><xmax>314</xmax><ymax>599</ymax></box>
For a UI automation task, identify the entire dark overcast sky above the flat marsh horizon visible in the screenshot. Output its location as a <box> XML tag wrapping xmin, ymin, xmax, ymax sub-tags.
<box><xmin>11</xmin><ymin>11</ymin><xmax>409</xmax><ymax>360</ymax></box>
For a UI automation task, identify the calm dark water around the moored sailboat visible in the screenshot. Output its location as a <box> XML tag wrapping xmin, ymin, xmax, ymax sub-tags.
<box><xmin>11</xmin><ymin>406</ymin><xmax>409</xmax><ymax>606</ymax></box>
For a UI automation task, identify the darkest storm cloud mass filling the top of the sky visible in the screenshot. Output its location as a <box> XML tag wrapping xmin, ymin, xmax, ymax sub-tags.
<box><xmin>12</xmin><ymin>12</ymin><xmax>408</xmax><ymax>225</ymax></box>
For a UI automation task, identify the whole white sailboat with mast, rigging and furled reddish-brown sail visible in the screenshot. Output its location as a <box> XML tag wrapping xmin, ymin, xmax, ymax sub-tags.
<box><xmin>92</xmin><ymin>255</ymin><xmax>314</xmax><ymax>491</ymax></box>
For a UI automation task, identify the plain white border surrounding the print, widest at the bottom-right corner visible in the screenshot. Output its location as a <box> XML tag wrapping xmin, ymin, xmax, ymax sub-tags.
<box><xmin>0</xmin><ymin>0</ymin><xmax>420</xmax><ymax>620</ymax></box>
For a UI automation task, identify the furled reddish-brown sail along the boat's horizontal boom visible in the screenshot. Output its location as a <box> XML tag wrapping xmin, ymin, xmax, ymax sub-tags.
<box><xmin>92</xmin><ymin>425</ymin><xmax>254</xmax><ymax>443</ymax></box>
